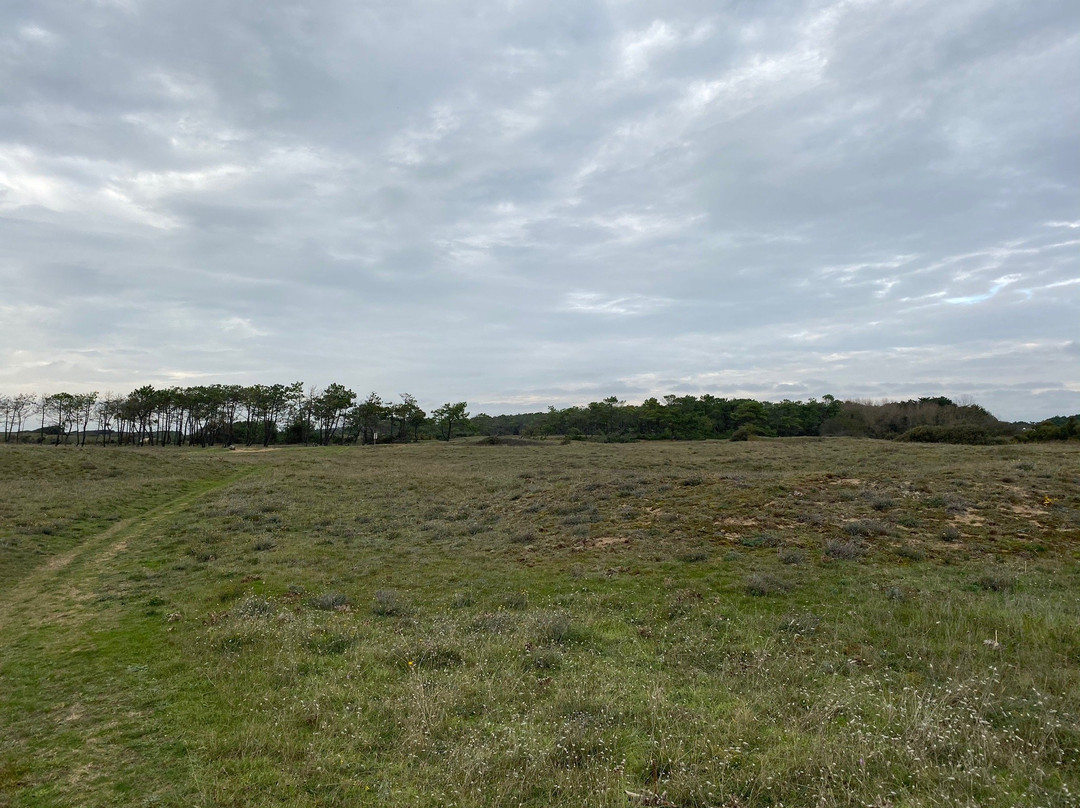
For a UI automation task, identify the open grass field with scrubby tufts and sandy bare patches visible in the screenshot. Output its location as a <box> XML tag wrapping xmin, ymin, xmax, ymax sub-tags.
<box><xmin>0</xmin><ymin>439</ymin><xmax>1080</xmax><ymax>808</ymax></box>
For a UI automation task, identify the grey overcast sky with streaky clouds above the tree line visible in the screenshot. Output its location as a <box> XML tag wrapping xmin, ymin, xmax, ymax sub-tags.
<box><xmin>0</xmin><ymin>0</ymin><xmax>1080</xmax><ymax>420</ymax></box>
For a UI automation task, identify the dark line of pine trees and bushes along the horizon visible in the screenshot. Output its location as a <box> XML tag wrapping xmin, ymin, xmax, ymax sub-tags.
<box><xmin>0</xmin><ymin>381</ymin><xmax>1080</xmax><ymax>446</ymax></box>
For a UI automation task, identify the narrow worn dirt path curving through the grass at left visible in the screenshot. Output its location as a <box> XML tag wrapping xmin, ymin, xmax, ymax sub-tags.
<box><xmin>0</xmin><ymin>477</ymin><xmax>237</xmax><ymax>634</ymax></box>
